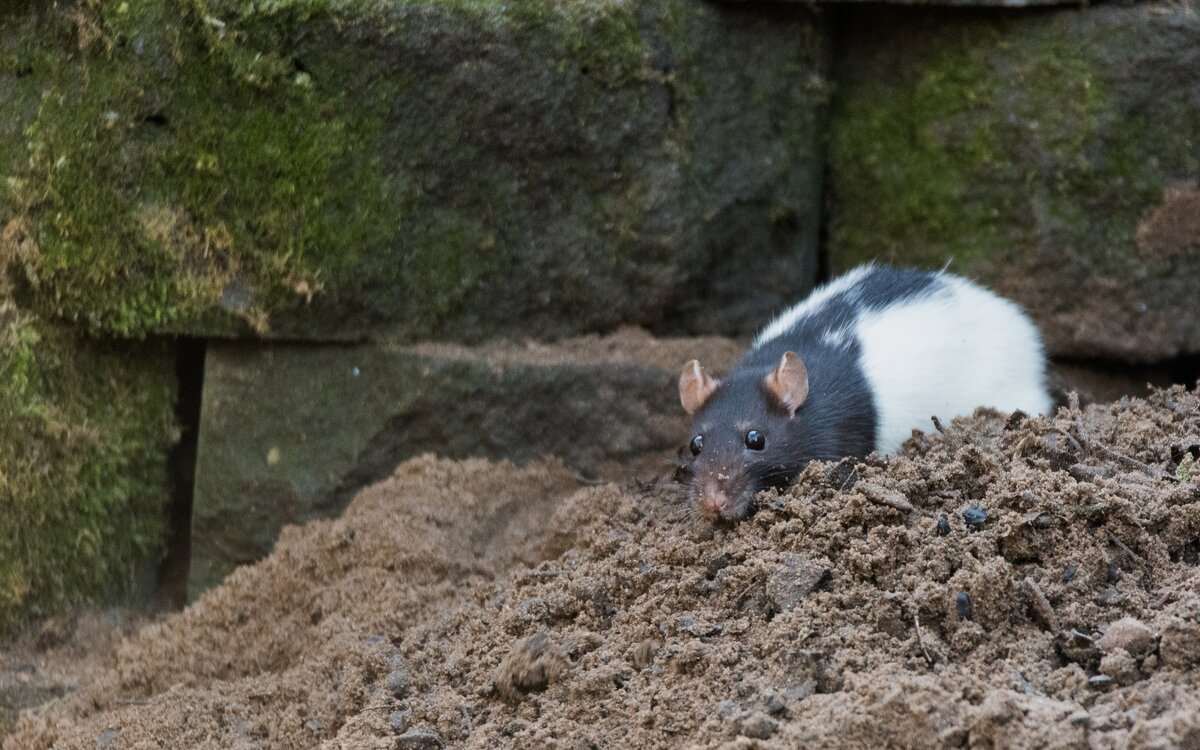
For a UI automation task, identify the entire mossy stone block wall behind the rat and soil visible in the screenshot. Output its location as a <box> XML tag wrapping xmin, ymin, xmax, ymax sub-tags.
<box><xmin>0</xmin><ymin>0</ymin><xmax>1200</xmax><ymax>629</ymax></box>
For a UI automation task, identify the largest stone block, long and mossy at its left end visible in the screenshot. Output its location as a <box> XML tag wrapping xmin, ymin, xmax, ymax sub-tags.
<box><xmin>0</xmin><ymin>0</ymin><xmax>827</xmax><ymax>341</ymax></box>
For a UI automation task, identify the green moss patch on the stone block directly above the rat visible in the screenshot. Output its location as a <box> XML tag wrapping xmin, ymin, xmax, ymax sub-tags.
<box><xmin>830</xmin><ymin>31</ymin><xmax>1007</xmax><ymax>265</ymax></box>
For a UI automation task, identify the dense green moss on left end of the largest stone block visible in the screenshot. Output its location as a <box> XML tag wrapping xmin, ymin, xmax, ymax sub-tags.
<box><xmin>9</xmin><ymin>1</ymin><xmax>396</xmax><ymax>336</ymax></box>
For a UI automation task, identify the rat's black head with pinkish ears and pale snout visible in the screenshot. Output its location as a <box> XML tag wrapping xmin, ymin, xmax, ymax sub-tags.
<box><xmin>679</xmin><ymin>352</ymin><xmax>809</xmax><ymax>521</ymax></box>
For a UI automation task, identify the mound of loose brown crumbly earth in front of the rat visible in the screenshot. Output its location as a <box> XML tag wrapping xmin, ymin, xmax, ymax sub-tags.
<box><xmin>4</xmin><ymin>386</ymin><xmax>1200</xmax><ymax>750</ymax></box>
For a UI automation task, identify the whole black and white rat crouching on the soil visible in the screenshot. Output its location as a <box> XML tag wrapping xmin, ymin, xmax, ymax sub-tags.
<box><xmin>679</xmin><ymin>264</ymin><xmax>1051</xmax><ymax>521</ymax></box>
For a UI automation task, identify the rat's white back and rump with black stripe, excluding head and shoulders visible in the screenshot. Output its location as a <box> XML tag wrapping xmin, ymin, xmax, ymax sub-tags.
<box><xmin>748</xmin><ymin>265</ymin><xmax>1051</xmax><ymax>452</ymax></box>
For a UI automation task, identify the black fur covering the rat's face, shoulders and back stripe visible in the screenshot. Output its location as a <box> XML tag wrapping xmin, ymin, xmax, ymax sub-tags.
<box><xmin>691</xmin><ymin>266</ymin><xmax>941</xmax><ymax>518</ymax></box>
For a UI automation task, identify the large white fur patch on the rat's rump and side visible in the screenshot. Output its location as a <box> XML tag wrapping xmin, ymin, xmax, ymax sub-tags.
<box><xmin>854</xmin><ymin>274</ymin><xmax>1051</xmax><ymax>452</ymax></box>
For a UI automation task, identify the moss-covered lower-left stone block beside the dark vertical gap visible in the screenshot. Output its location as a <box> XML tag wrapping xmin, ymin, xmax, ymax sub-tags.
<box><xmin>0</xmin><ymin>306</ymin><xmax>175</xmax><ymax>631</ymax></box>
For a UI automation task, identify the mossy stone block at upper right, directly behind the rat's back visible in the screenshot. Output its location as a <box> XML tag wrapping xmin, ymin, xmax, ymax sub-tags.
<box><xmin>829</xmin><ymin>4</ymin><xmax>1200</xmax><ymax>362</ymax></box>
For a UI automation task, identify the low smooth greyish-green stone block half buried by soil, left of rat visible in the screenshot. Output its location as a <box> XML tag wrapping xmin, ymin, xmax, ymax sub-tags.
<box><xmin>190</xmin><ymin>332</ymin><xmax>740</xmax><ymax>594</ymax></box>
